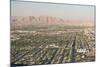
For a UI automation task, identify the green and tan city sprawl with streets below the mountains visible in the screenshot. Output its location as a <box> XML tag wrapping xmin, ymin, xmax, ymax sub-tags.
<box><xmin>11</xmin><ymin>27</ymin><xmax>95</xmax><ymax>65</ymax></box>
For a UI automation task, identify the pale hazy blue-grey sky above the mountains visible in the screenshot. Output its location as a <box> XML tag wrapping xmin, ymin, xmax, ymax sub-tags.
<box><xmin>11</xmin><ymin>1</ymin><xmax>95</xmax><ymax>20</ymax></box>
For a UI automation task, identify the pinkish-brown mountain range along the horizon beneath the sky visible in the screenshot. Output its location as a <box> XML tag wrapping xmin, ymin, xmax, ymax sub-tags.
<box><xmin>11</xmin><ymin>16</ymin><xmax>94</xmax><ymax>28</ymax></box>
